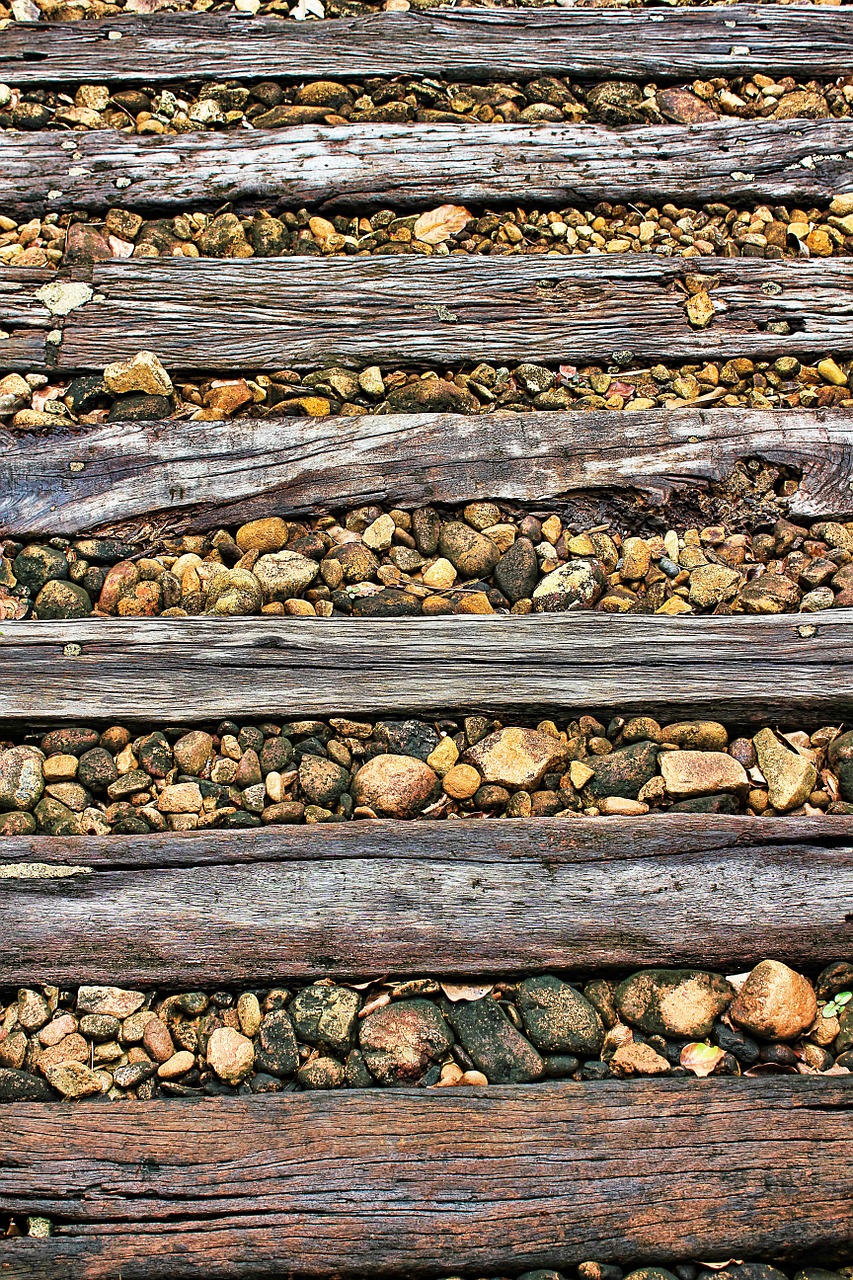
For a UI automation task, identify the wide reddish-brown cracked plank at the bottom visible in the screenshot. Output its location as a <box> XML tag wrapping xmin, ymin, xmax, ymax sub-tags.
<box><xmin>0</xmin><ymin>1076</ymin><xmax>853</xmax><ymax>1280</ymax></box>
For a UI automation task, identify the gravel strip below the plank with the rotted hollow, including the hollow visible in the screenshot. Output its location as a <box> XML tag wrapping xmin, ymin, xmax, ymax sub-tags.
<box><xmin>9</xmin><ymin>481</ymin><xmax>853</xmax><ymax>621</ymax></box>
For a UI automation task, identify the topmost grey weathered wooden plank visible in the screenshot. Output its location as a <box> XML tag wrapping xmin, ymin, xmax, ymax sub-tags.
<box><xmin>0</xmin><ymin>4</ymin><xmax>853</xmax><ymax>84</ymax></box>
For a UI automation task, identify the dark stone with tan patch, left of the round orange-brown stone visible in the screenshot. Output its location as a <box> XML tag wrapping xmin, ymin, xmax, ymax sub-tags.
<box><xmin>615</xmin><ymin>969</ymin><xmax>734</xmax><ymax>1039</ymax></box>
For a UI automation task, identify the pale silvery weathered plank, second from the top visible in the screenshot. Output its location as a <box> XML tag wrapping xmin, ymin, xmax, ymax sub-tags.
<box><xmin>0</xmin><ymin>116</ymin><xmax>853</xmax><ymax>216</ymax></box>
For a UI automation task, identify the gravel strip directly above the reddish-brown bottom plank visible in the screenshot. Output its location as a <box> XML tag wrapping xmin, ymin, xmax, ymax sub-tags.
<box><xmin>0</xmin><ymin>960</ymin><xmax>853</xmax><ymax>1102</ymax></box>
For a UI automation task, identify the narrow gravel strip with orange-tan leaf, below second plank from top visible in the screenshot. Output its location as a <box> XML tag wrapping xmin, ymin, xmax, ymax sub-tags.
<box><xmin>6</xmin><ymin>196</ymin><xmax>853</xmax><ymax>266</ymax></box>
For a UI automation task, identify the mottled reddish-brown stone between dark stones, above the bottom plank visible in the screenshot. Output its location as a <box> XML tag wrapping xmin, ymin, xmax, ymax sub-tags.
<box><xmin>359</xmin><ymin>1000</ymin><xmax>453</xmax><ymax>1085</ymax></box>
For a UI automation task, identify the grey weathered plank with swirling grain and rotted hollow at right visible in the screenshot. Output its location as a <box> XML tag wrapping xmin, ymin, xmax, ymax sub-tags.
<box><xmin>0</xmin><ymin>408</ymin><xmax>853</xmax><ymax>536</ymax></box>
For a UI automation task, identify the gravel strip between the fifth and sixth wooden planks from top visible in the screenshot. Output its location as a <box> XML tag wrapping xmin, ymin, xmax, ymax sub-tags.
<box><xmin>0</xmin><ymin>714</ymin><xmax>853</xmax><ymax>847</ymax></box>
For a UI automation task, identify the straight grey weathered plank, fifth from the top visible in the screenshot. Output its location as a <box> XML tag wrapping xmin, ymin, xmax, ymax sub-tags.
<box><xmin>0</xmin><ymin>609</ymin><xmax>853</xmax><ymax>723</ymax></box>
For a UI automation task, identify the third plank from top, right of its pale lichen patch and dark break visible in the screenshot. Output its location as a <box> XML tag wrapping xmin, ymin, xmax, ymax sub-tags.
<box><xmin>28</xmin><ymin>255</ymin><xmax>853</xmax><ymax>370</ymax></box>
